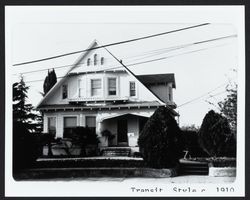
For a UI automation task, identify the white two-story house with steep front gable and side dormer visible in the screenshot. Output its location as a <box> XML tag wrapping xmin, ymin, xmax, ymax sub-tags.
<box><xmin>37</xmin><ymin>41</ymin><xmax>177</xmax><ymax>153</ymax></box>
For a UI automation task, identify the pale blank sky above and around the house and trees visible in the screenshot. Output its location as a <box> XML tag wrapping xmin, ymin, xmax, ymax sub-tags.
<box><xmin>6</xmin><ymin>6</ymin><xmax>241</xmax><ymax>126</ymax></box>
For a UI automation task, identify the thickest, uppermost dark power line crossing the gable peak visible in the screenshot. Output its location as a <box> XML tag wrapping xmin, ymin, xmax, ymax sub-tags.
<box><xmin>13</xmin><ymin>23</ymin><xmax>210</xmax><ymax>66</ymax></box>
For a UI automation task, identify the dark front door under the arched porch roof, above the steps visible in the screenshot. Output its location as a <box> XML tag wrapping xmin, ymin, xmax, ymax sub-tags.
<box><xmin>117</xmin><ymin>119</ymin><xmax>128</xmax><ymax>146</ymax></box>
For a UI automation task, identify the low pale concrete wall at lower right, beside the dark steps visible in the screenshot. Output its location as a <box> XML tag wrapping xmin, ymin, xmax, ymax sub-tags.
<box><xmin>208</xmin><ymin>167</ymin><xmax>236</xmax><ymax>177</ymax></box>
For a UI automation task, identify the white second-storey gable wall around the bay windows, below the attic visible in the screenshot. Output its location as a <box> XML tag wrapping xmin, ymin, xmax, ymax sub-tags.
<box><xmin>44</xmin><ymin>72</ymin><xmax>164</xmax><ymax>105</ymax></box>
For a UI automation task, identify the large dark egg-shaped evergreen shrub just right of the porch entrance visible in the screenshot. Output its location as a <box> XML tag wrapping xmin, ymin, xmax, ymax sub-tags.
<box><xmin>138</xmin><ymin>108</ymin><xmax>183</xmax><ymax>168</ymax></box>
